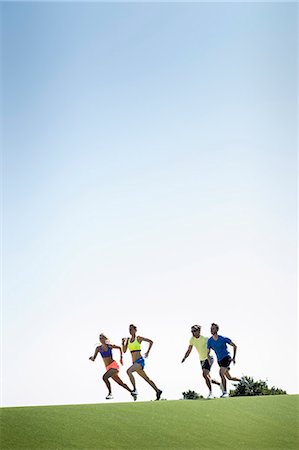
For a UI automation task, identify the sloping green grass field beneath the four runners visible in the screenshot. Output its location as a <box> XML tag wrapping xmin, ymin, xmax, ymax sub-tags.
<box><xmin>0</xmin><ymin>395</ymin><xmax>299</xmax><ymax>450</ymax></box>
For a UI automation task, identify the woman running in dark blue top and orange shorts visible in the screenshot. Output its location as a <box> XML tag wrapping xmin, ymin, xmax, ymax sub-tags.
<box><xmin>89</xmin><ymin>334</ymin><xmax>137</xmax><ymax>400</ymax></box>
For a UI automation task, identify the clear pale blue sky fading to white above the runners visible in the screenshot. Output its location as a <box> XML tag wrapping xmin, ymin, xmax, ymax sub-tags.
<box><xmin>1</xmin><ymin>3</ymin><xmax>298</xmax><ymax>406</ymax></box>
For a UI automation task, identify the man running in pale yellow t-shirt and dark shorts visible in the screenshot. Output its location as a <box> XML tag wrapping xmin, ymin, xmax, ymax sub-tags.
<box><xmin>182</xmin><ymin>325</ymin><xmax>220</xmax><ymax>398</ymax></box>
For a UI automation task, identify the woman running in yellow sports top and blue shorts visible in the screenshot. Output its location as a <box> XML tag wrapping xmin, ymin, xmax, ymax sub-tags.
<box><xmin>122</xmin><ymin>324</ymin><xmax>162</xmax><ymax>400</ymax></box>
